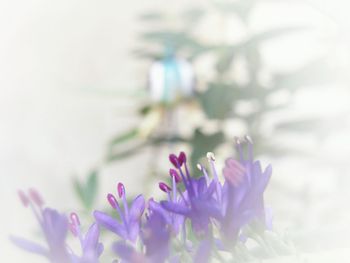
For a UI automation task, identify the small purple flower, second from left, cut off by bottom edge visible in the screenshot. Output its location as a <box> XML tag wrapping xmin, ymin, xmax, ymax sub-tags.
<box><xmin>69</xmin><ymin>213</ymin><xmax>103</xmax><ymax>263</ymax></box>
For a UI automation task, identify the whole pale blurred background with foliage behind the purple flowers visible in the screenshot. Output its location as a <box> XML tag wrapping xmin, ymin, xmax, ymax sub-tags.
<box><xmin>0</xmin><ymin>0</ymin><xmax>350</xmax><ymax>262</ymax></box>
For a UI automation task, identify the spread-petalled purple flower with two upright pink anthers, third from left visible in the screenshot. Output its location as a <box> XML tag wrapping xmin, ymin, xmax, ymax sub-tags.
<box><xmin>94</xmin><ymin>183</ymin><xmax>145</xmax><ymax>243</ymax></box>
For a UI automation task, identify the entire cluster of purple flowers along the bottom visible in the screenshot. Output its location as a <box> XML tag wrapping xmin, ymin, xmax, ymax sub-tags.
<box><xmin>12</xmin><ymin>136</ymin><xmax>272</xmax><ymax>263</ymax></box>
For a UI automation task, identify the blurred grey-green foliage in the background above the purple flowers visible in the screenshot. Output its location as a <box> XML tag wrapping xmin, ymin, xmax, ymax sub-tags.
<box><xmin>76</xmin><ymin>0</ymin><xmax>329</xmax><ymax>207</ymax></box>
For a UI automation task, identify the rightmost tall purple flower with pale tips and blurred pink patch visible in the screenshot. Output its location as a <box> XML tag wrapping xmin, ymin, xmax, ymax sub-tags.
<box><xmin>221</xmin><ymin>136</ymin><xmax>272</xmax><ymax>245</ymax></box>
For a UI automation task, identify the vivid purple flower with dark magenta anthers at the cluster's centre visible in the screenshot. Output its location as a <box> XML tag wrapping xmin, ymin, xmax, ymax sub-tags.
<box><xmin>160</xmin><ymin>152</ymin><xmax>221</xmax><ymax>234</ymax></box>
